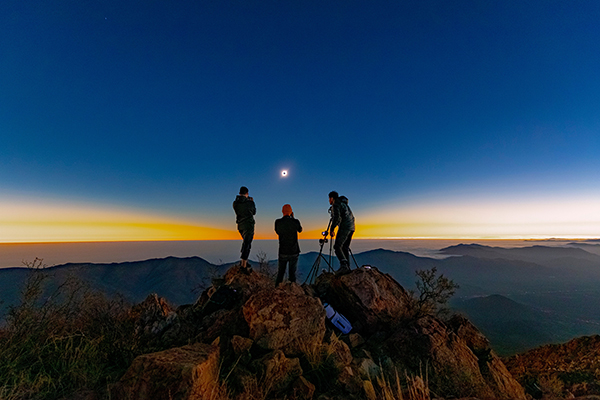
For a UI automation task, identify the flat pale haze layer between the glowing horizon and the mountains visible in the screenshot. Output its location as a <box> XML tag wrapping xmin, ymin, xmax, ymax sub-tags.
<box><xmin>0</xmin><ymin>239</ymin><xmax>584</xmax><ymax>268</ymax></box>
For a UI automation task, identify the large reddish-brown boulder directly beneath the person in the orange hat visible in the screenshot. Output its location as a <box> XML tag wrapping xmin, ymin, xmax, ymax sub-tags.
<box><xmin>243</xmin><ymin>283</ymin><xmax>325</xmax><ymax>355</ymax></box>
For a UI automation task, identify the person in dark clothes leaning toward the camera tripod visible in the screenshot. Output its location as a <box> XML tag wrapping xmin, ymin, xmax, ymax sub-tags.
<box><xmin>329</xmin><ymin>191</ymin><xmax>355</xmax><ymax>273</ymax></box>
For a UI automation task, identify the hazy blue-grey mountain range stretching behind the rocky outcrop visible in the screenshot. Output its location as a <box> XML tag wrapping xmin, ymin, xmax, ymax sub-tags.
<box><xmin>0</xmin><ymin>244</ymin><xmax>600</xmax><ymax>355</ymax></box>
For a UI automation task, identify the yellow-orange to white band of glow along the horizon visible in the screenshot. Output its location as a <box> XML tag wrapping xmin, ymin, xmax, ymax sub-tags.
<box><xmin>0</xmin><ymin>196</ymin><xmax>600</xmax><ymax>243</ymax></box>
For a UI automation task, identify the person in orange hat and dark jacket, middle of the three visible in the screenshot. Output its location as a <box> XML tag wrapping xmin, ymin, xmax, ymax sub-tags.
<box><xmin>275</xmin><ymin>204</ymin><xmax>302</xmax><ymax>286</ymax></box>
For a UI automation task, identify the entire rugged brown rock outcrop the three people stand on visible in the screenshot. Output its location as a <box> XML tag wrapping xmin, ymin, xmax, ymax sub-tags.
<box><xmin>111</xmin><ymin>266</ymin><xmax>526</xmax><ymax>400</ymax></box>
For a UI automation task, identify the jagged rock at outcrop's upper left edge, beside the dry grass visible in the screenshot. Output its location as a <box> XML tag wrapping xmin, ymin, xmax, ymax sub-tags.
<box><xmin>131</xmin><ymin>293</ymin><xmax>177</xmax><ymax>337</ymax></box>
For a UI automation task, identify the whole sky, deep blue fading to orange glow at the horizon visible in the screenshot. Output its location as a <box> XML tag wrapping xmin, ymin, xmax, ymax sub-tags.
<box><xmin>0</xmin><ymin>0</ymin><xmax>600</xmax><ymax>242</ymax></box>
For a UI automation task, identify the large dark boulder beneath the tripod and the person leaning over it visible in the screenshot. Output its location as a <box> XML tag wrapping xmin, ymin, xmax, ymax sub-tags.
<box><xmin>316</xmin><ymin>267</ymin><xmax>409</xmax><ymax>334</ymax></box>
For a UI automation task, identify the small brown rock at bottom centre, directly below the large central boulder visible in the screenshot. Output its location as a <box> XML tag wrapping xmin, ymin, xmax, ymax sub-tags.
<box><xmin>253</xmin><ymin>350</ymin><xmax>302</xmax><ymax>393</ymax></box>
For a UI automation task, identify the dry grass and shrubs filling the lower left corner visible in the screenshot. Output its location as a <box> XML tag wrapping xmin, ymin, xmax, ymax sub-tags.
<box><xmin>0</xmin><ymin>259</ymin><xmax>139</xmax><ymax>399</ymax></box>
